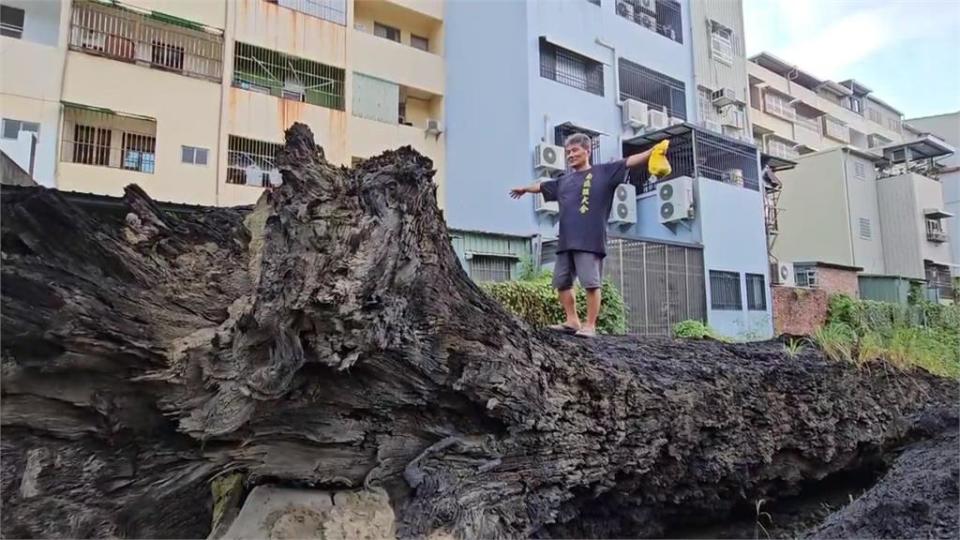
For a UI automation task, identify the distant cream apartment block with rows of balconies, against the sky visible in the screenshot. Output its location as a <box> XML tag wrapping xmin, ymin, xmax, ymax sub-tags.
<box><xmin>747</xmin><ymin>53</ymin><xmax>903</xmax><ymax>160</ymax></box>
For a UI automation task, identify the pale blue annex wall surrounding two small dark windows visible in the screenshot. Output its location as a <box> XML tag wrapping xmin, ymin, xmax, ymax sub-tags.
<box><xmin>697</xmin><ymin>178</ymin><xmax>773</xmax><ymax>339</ymax></box>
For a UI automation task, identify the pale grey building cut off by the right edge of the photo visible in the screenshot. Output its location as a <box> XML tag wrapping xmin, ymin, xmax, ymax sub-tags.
<box><xmin>906</xmin><ymin>111</ymin><xmax>960</xmax><ymax>277</ymax></box>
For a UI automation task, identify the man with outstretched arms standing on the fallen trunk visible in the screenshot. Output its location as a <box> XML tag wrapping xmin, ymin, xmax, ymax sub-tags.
<box><xmin>510</xmin><ymin>133</ymin><xmax>669</xmax><ymax>337</ymax></box>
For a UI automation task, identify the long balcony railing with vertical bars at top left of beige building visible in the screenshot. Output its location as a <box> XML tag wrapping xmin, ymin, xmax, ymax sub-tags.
<box><xmin>70</xmin><ymin>2</ymin><xmax>223</xmax><ymax>81</ymax></box>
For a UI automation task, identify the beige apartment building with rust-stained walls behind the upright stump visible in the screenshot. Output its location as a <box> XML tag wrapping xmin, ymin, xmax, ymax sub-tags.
<box><xmin>0</xmin><ymin>0</ymin><xmax>445</xmax><ymax>205</ymax></box>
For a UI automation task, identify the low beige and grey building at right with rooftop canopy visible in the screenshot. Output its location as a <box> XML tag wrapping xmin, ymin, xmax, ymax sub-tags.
<box><xmin>772</xmin><ymin>135</ymin><xmax>954</xmax><ymax>302</ymax></box>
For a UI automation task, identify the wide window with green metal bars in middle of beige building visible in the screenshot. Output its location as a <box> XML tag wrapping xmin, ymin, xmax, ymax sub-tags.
<box><xmin>233</xmin><ymin>42</ymin><xmax>344</xmax><ymax>111</ymax></box>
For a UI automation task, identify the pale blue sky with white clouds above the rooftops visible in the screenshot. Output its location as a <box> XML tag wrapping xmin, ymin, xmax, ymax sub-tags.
<box><xmin>744</xmin><ymin>0</ymin><xmax>960</xmax><ymax>118</ymax></box>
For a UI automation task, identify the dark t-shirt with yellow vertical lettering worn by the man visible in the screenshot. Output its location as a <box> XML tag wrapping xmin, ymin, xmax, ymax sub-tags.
<box><xmin>540</xmin><ymin>160</ymin><xmax>627</xmax><ymax>256</ymax></box>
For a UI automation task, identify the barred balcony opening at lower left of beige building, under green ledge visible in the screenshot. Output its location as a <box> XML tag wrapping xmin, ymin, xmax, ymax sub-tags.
<box><xmin>60</xmin><ymin>105</ymin><xmax>157</xmax><ymax>174</ymax></box>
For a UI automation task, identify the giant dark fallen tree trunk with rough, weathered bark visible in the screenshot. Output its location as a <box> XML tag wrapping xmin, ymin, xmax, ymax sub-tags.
<box><xmin>2</xmin><ymin>125</ymin><xmax>957</xmax><ymax>538</ymax></box>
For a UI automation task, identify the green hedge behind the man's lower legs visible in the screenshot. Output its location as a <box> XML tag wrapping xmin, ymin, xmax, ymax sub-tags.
<box><xmin>480</xmin><ymin>274</ymin><xmax>627</xmax><ymax>334</ymax></box>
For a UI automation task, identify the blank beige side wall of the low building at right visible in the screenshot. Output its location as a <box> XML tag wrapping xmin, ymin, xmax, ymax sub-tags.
<box><xmin>773</xmin><ymin>149</ymin><xmax>854</xmax><ymax>266</ymax></box>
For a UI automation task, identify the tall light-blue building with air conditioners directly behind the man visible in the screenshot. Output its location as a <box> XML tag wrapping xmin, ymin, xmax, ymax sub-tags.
<box><xmin>445</xmin><ymin>0</ymin><xmax>772</xmax><ymax>337</ymax></box>
